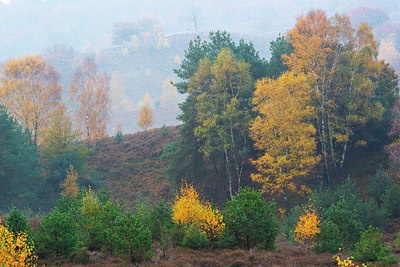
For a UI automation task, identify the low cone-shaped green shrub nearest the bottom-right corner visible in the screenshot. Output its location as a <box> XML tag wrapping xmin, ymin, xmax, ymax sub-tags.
<box><xmin>352</xmin><ymin>226</ymin><xmax>398</xmax><ymax>265</ymax></box>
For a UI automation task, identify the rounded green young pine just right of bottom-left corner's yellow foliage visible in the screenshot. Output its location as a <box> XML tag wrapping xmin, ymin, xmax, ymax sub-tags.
<box><xmin>34</xmin><ymin>209</ymin><xmax>78</xmax><ymax>257</ymax></box>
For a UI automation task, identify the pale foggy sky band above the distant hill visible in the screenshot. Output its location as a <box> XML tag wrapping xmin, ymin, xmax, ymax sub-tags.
<box><xmin>0</xmin><ymin>0</ymin><xmax>400</xmax><ymax>60</ymax></box>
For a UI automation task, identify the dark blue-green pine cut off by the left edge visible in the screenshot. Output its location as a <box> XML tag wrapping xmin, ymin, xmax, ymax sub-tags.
<box><xmin>0</xmin><ymin>106</ymin><xmax>39</xmax><ymax>209</ymax></box>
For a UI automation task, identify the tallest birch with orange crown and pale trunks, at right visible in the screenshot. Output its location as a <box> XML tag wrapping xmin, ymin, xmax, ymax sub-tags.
<box><xmin>283</xmin><ymin>10</ymin><xmax>390</xmax><ymax>183</ymax></box>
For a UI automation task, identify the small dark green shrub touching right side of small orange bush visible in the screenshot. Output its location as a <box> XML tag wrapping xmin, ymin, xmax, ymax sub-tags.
<box><xmin>314</xmin><ymin>221</ymin><xmax>340</xmax><ymax>253</ymax></box>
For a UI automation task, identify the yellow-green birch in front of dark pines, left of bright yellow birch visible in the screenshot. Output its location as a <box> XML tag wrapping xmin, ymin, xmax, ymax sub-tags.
<box><xmin>189</xmin><ymin>48</ymin><xmax>252</xmax><ymax>198</ymax></box>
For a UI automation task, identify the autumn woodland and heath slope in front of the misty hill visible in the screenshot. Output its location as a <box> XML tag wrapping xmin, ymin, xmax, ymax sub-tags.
<box><xmin>0</xmin><ymin>10</ymin><xmax>400</xmax><ymax>266</ymax></box>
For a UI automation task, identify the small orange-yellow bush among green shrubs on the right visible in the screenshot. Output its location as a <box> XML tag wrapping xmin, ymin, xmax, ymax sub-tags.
<box><xmin>294</xmin><ymin>206</ymin><xmax>321</xmax><ymax>246</ymax></box>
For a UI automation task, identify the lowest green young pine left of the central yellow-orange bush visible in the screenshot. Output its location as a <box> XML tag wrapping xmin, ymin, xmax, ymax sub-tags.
<box><xmin>113</xmin><ymin>211</ymin><xmax>152</xmax><ymax>263</ymax></box>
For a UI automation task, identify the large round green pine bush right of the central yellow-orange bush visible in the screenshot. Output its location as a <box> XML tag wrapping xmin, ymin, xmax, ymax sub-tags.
<box><xmin>224</xmin><ymin>188</ymin><xmax>279</xmax><ymax>250</ymax></box>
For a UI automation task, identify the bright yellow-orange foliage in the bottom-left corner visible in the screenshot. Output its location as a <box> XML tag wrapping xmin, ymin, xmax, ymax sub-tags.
<box><xmin>0</xmin><ymin>221</ymin><xmax>36</xmax><ymax>267</ymax></box>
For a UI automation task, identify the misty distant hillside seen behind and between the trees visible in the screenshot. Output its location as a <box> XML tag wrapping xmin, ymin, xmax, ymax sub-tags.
<box><xmin>43</xmin><ymin>33</ymin><xmax>275</xmax><ymax>136</ymax></box>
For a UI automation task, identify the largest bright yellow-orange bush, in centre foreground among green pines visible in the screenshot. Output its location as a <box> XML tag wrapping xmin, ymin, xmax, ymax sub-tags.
<box><xmin>172</xmin><ymin>183</ymin><xmax>225</xmax><ymax>240</ymax></box>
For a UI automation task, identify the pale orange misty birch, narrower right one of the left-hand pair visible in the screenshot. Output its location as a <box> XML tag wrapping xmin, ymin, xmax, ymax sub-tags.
<box><xmin>69</xmin><ymin>58</ymin><xmax>110</xmax><ymax>142</ymax></box>
